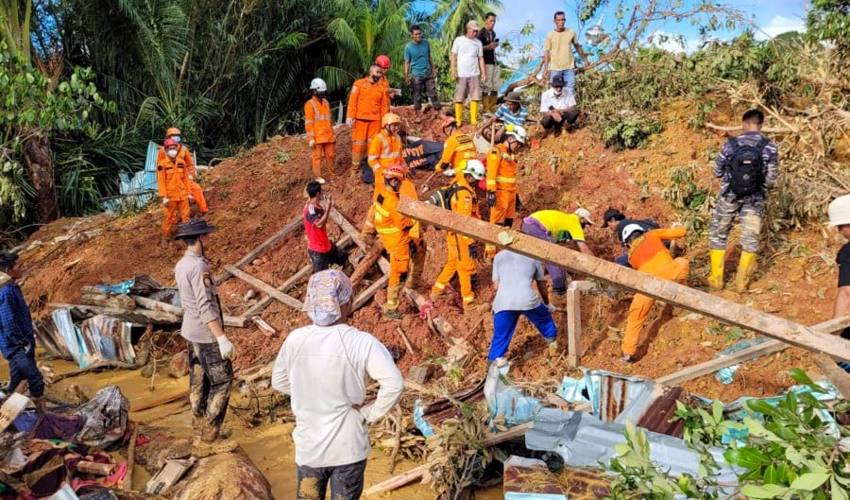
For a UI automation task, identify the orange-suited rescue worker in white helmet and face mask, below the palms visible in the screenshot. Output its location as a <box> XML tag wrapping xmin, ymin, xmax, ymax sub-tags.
<box><xmin>304</xmin><ymin>78</ymin><xmax>336</xmax><ymax>184</ymax></box>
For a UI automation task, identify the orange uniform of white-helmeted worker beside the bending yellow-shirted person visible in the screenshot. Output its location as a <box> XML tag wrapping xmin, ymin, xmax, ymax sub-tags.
<box><xmin>486</xmin><ymin>143</ymin><xmax>519</xmax><ymax>259</ymax></box>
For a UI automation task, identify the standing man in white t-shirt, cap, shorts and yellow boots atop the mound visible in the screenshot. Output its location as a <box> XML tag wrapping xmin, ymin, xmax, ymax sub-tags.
<box><xmin>451</xmin><ymin>20</ymin><xmax>487</xmax><ymax>127</ymax></box>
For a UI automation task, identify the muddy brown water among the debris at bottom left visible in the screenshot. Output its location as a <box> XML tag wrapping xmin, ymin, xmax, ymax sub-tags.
<box><xmin>36</xmin><ymin>361</ymin><xmax>504</xmax><ymax>500</ymax></box>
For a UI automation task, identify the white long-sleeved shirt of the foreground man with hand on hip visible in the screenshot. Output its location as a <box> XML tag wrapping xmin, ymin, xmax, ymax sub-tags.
<box><xmin>272</xmin><ymin>324</ymin><xmax>404</xmax><ymax>467</ymax></box>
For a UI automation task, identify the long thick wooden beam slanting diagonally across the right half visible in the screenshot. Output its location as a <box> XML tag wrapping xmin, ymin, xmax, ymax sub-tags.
<box><xmin>398</xmin><ymin>197</ymin><xmax>850</xmax><ymax>361</ymax></box>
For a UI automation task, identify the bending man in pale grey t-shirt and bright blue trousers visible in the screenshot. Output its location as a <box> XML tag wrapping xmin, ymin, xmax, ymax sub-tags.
<box><xmin>487</xmin><ymin>250</ymin><xmax>558</xmax><ymax>363</ymax></box>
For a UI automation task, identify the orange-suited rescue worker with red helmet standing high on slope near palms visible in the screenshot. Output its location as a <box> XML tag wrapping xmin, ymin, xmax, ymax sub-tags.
<box><xmin>345</xmin><ymin>64</ymin><xmax>390</xmax><ymax>167</ymax></box>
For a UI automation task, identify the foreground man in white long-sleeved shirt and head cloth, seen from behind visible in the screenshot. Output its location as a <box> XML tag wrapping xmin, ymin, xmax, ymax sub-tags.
<box><xmin>272</xmin><ymin>269</ymin><xmax>404</xmax><ymax>500</ymax></box>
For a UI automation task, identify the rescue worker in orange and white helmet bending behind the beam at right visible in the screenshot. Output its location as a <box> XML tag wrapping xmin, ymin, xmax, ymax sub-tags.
<box><xmin>620</xmin><ymin>223</ymin><xmax>691</xmax><ymax>364</ymax></box>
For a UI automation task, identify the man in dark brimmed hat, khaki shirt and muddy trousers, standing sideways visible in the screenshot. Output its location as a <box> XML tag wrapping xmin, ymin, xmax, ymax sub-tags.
<box><xmin>174</xmin><ymin>219</ymin><xmax>236</xmax><ymax>456</ymax></box>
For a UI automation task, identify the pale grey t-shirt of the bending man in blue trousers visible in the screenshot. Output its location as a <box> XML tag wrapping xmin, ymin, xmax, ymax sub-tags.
<box><xmin>493</xmin><ymin>250</ymin><xmax>546</xmax><ymax>314</ymax></box>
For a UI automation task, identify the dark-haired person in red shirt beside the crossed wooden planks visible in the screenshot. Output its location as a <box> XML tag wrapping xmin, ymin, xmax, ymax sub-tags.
<box><xmin>304</xmin><ymin>181</ymin><xmax>348</xmax><ymax>273</ymax></box>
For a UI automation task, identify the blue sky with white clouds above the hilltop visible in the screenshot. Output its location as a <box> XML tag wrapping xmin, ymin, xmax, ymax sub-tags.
<box><xmin>418</xmin><ymin>0</ymin><xmax>808</xmax><ymax>64</ymax></box>
